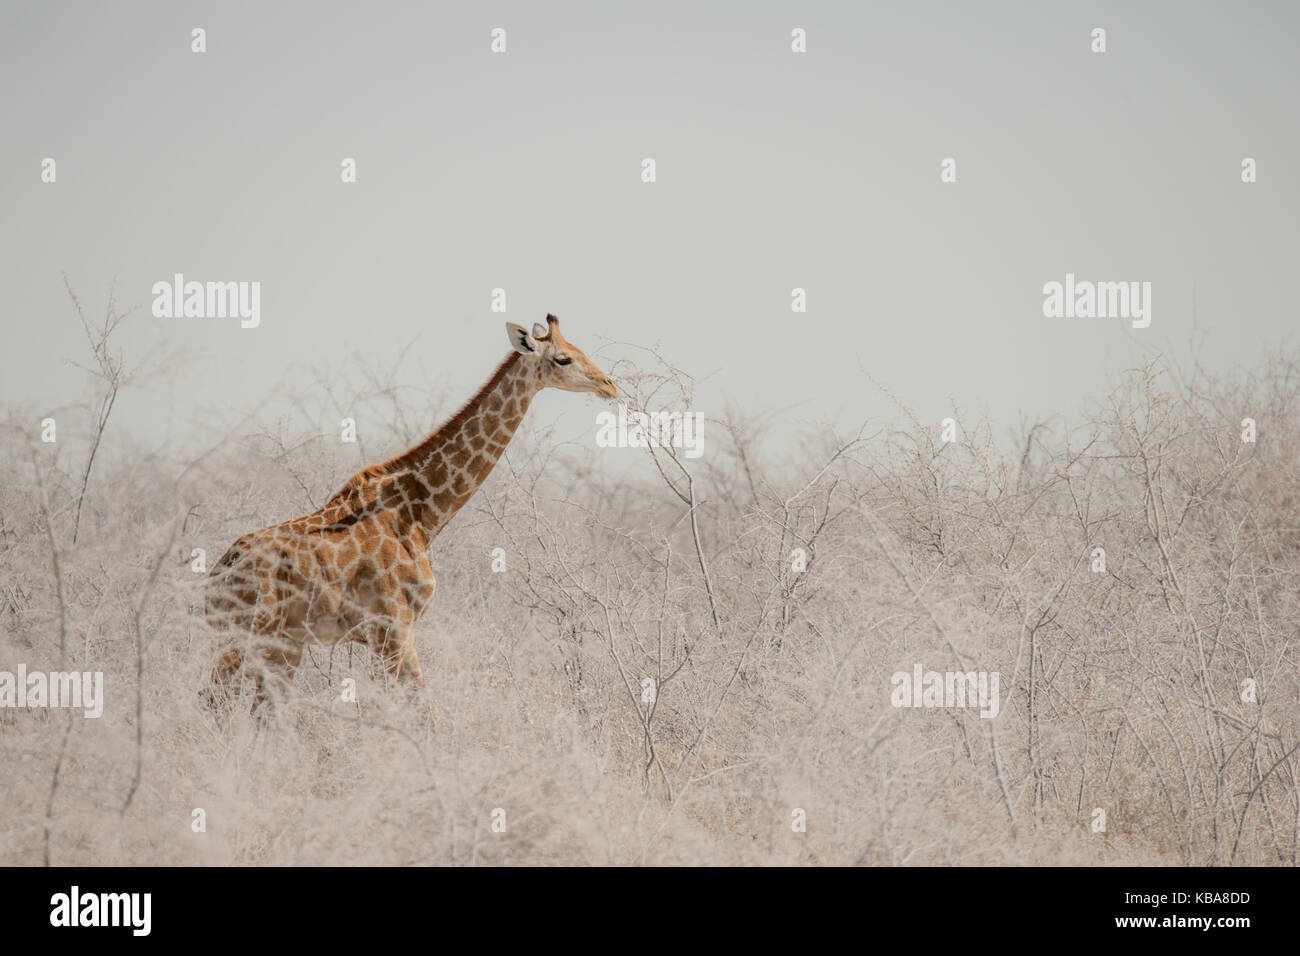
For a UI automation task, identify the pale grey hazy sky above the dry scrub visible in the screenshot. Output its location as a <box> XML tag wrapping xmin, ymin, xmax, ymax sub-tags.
<box><xmin>0</xmin><ymin>0</ymin><xmax>1300</xmax><ymax>453</ymax></box>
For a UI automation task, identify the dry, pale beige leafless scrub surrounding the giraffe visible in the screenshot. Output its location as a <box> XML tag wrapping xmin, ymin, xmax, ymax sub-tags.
<box><xmin>0</xmin><ymin>300</ymin><xmax>1300</xmax><ymax>865</ymax></box>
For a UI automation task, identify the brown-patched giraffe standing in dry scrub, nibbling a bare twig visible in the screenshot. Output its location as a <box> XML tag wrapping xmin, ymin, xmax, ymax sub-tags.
<box><xmin>204</xmin><ymin>315</ymin><xmax>619</xmax><ymax>708</ymax></box>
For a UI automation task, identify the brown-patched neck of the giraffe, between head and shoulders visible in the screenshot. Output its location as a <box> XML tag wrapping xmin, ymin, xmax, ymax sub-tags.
<box><xmin>387</xmin><ymin>352</ymin><xmax>541</xmax><ymax>540</ymax></box>
